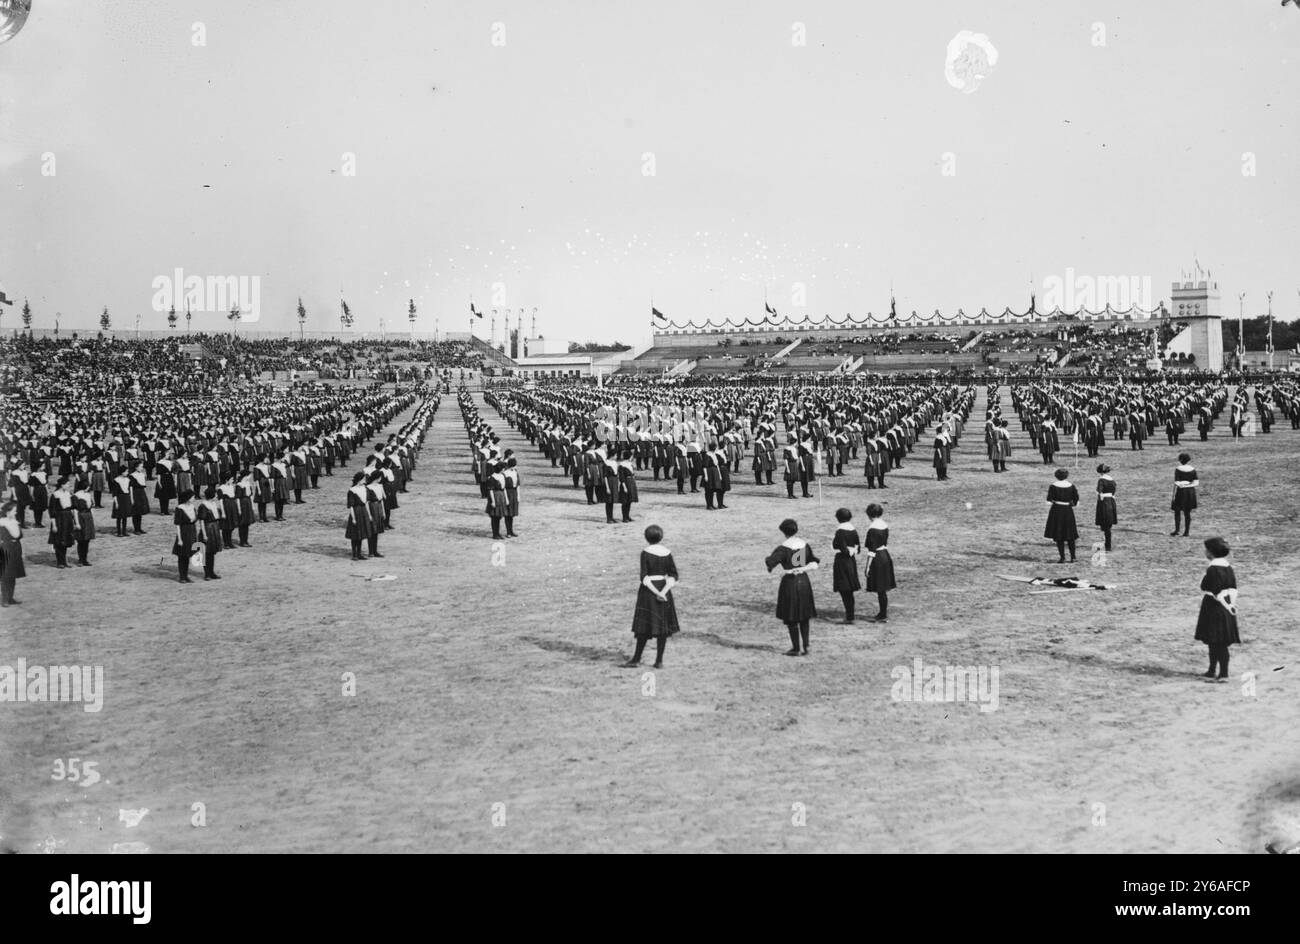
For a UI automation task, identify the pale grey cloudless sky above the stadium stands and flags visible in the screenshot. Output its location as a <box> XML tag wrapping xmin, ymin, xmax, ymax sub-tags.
<box><xmin>0</xmin><ymin>0</ymin><xmax>1300</xmax><ymax>345</ymax></box>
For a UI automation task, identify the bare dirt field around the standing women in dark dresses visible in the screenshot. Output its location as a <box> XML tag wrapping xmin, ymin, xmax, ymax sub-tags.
<box><xmin>0</xmin><ymin>384</ymin><xmax>1300</xmax><ymax>853</ymax></box>
